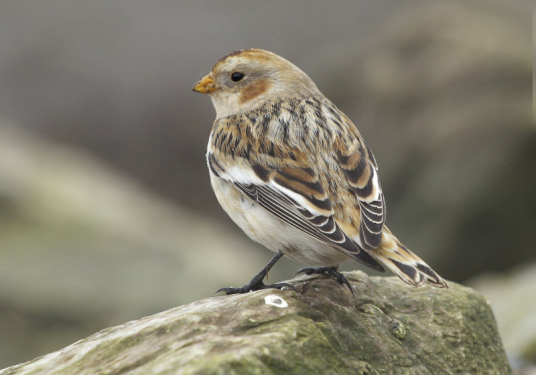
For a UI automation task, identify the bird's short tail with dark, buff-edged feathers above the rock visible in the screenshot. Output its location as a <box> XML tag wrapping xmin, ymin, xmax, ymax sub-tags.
<box><xmin>368</xmin><ymin>227</ymin><xmax>449</xmax><ymax>288</ymax></box>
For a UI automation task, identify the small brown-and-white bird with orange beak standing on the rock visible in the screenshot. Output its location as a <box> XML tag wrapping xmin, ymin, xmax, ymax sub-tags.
<box><xmin>192</xmin><ymin>48</ymin><xmax>448</xmax><ymax>295</ymax></box>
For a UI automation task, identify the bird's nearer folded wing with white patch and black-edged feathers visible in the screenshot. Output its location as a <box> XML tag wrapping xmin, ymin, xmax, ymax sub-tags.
<box><xmin>207</xmin><ymin>153</ymin><xmax>384</xmax><ymax>271</ymax></box>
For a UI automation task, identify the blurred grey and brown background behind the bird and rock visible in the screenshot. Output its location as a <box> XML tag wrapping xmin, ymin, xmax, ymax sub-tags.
<box><xmin>0</xmin><ymin>0</ymin><xmax>536</xmax><ymax>374</ymax></box>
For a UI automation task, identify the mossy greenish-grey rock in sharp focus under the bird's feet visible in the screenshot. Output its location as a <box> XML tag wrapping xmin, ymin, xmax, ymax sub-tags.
<box><xmin>0</xmin><ymin>272</ymin><xmax>511</xmax><ymax>375</ymax></box>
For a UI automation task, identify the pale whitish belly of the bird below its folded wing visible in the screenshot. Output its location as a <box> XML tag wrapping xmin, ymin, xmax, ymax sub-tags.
<box><xmin>210</xmin><ymin>173</ymin><xmax>351</xmax><ymax>266</ymax></box>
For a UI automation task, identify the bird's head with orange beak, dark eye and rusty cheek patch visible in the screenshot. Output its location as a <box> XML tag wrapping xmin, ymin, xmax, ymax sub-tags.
<box><xmin>192</xmin><ymin>49</ymin><xmax>318</xmax><ymax>118</ymax></box>
